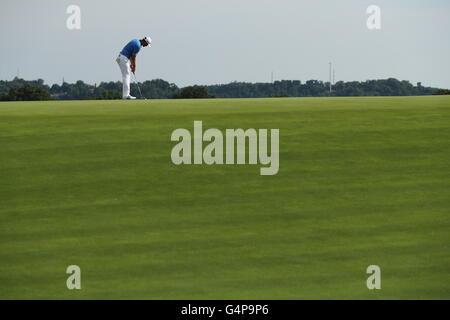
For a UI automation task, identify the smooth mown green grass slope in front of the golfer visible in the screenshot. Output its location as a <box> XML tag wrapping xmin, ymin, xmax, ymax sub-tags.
<box><xmin>0</xmin><ymin>97</ymin><xmax>450</xmax><ymax>299</ymax></box>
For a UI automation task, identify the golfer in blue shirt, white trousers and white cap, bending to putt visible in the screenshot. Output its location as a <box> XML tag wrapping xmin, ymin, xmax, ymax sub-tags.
<box><xmin>116</xmin><ymin>37</ymin><xmax>152</xmax><ymax>99</ymax></box>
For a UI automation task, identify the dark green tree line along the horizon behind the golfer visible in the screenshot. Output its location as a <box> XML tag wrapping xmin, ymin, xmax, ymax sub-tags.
<box><xmin>0</xmin><ymin>77</ymin><xmax>444</xmax><ymax>101</ymax></box>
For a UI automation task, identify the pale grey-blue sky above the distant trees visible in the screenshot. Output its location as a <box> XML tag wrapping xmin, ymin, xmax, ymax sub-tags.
<box><xmin>0</xmin><ymin>0</ymin><xmax>450</xmax><ymax>88</ymax></box>
